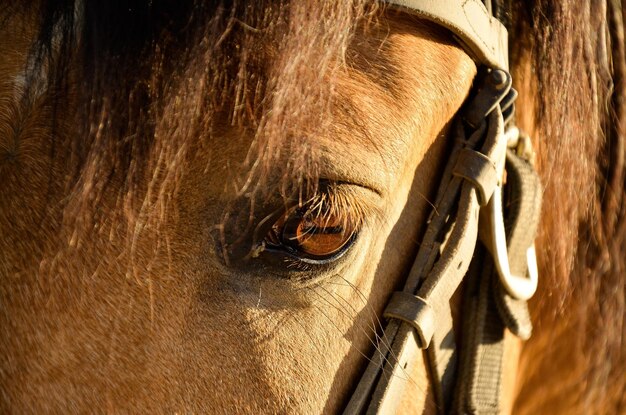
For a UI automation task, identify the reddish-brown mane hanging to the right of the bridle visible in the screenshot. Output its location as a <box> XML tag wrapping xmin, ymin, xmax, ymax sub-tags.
<box><xmin>511</xmin><ymin>0</ymin><xmax>626</xmax><ymax>413</ymax></box>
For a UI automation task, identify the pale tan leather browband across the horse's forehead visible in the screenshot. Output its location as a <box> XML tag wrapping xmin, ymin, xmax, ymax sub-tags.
<box><xmin>386</xmin><ymin>0</ymin><xmax>509</xmax><ymax>71</ymax></box>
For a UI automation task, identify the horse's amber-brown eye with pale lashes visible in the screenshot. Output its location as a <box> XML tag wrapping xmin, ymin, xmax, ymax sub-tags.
<box><xmin>265</xmin><ymin>208</ymin><xmax>357</xmax><ymax>260</ymax></box>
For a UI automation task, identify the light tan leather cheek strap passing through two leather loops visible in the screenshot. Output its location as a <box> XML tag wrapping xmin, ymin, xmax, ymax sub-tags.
<box><xmin>345</xmin><ymin>75</ymin><xmax>510</xmax><ymax>414</ymax></box>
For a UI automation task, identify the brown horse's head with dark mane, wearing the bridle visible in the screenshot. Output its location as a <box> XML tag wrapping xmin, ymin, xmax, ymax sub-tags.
<box><xmin>0</xmin><ymin>0</ymin><xmax>626</xmax><ymax>414</ymax></box>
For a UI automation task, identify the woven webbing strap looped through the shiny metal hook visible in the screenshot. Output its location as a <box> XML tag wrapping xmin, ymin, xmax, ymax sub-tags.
<box><xmin>454</xmin><ymin>150</ymin><xmax>542</xmax><ymax>414</ymax></box>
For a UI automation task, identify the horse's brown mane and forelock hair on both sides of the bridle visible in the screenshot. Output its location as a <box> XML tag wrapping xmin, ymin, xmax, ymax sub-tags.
<box><xmin>0</xmin><ymin>0</ymin><xmax>626</xmax><ymax>413</ymax></box>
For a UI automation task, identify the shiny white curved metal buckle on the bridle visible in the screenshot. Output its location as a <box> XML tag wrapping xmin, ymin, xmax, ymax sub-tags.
<box><xmin>480</xmin><ymin>127</ymin><xmax>539</xmax><ymax>300</ymax></box>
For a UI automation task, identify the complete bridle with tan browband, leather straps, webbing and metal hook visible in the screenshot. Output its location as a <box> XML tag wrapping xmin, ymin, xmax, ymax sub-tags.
<box><xmin>344</xmin><ymin>0</ymin><xmax>542</xmax><ymax>414</ymax></box>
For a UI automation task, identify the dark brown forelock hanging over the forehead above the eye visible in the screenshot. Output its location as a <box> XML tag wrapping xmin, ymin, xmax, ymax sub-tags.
<box><xmin>13</xmin><ymin>0</ymin><xmax>386</xmax><ymax>250</ymax></box>
